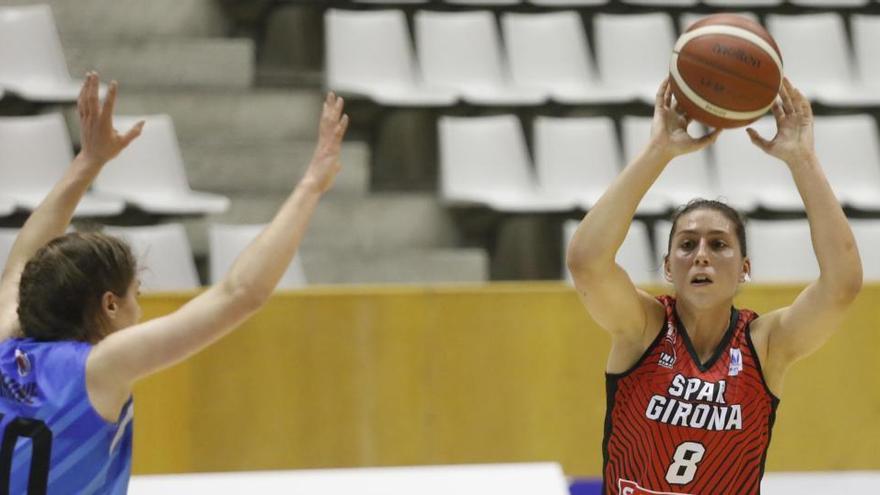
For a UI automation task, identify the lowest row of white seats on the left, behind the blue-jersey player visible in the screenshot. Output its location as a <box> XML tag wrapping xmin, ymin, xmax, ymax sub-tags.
<box><xmin>0</xmin><ymin>223</ymin><xmax>306</xmax><ymax>292</ymax></box>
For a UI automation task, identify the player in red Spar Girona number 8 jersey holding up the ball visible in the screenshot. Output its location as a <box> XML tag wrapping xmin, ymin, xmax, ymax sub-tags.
<box><xmin>567</xmin><ymin>80</ymin><xmax>862</xmax><ymax>495</ymax></box>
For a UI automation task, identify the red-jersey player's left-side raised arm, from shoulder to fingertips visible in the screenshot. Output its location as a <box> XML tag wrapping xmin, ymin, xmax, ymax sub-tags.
<box><xmin>566</xmin><ymin>80</ymin><xmax>718</xmax><ymax>367</ymax></box>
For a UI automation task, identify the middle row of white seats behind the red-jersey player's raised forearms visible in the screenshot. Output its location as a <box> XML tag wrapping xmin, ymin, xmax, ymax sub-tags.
<box><xmin>438</xmin><ymin>114</ymin><xmax>880</xmax><ymax>215</ymax></box>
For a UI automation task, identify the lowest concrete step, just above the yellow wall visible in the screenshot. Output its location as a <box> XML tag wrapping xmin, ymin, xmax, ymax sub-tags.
<box><xmin>302</xmin><ymin>248</ymin><xmax>489</xmax><ymax>284</ymax></box>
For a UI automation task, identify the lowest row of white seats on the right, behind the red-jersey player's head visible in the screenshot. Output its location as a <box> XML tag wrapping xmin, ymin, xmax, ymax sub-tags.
<box><xmin>563</xmin><ymin>220</ymin><xmax>880</xmax><ymax>284</ymax></box>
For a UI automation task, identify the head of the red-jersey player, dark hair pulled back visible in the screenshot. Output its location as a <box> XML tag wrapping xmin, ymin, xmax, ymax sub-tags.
<box><xmin>664</xmin><ymin>208</ymin><xmax>749</xmax><ymax>307</ymax></box>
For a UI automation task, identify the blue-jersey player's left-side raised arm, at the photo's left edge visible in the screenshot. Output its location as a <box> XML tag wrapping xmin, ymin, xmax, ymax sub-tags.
<box><xmin>0</xmin><ymin>72</ymin><xmax>143</xmax><ymax>340</ymax></box>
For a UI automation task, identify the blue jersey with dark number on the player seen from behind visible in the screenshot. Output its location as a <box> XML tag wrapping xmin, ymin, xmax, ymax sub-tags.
<box><xmin>0</xmin><ymin>339</ymin><xmax>133</xmax><ymax>494</ymax></box>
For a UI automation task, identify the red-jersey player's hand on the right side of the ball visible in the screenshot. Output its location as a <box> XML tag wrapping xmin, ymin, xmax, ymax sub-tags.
<box><xmin>746</xmin><ymin>78</ymin><xmax>815</xmax><ymax>165</ymax></box>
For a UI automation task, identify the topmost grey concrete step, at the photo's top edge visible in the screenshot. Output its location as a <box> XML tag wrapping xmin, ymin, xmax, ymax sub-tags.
<box><xmin>0</xmin><ymin>0</ymin><xmax>230</xmax><ymax>42</ymax></box>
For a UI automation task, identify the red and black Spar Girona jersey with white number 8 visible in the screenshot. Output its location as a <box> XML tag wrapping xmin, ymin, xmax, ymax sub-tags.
<box><xmin>603</xmin><ymin>296</ymin><xmax>779</xmax><ymax>495</ymax></box>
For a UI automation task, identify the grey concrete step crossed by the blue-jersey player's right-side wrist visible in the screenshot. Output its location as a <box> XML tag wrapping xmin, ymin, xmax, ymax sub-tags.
<box><xmin>181</xmin><ymin>140</ymin><xmax>370</xmax><ymax>196</ymax></box>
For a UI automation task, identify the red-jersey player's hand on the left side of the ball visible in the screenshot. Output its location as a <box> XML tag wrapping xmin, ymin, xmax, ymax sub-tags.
<box><xmin>651</xmin><ymin>78</ymin><xmax>721</xmax><ymax>158</ymax></box>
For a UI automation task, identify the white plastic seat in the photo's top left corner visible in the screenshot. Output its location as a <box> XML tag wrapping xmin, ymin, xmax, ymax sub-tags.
<box><xmin>0</xmin><ymin>5</ymin><xmax>87</xmax><ymax>102</ymax></box>
